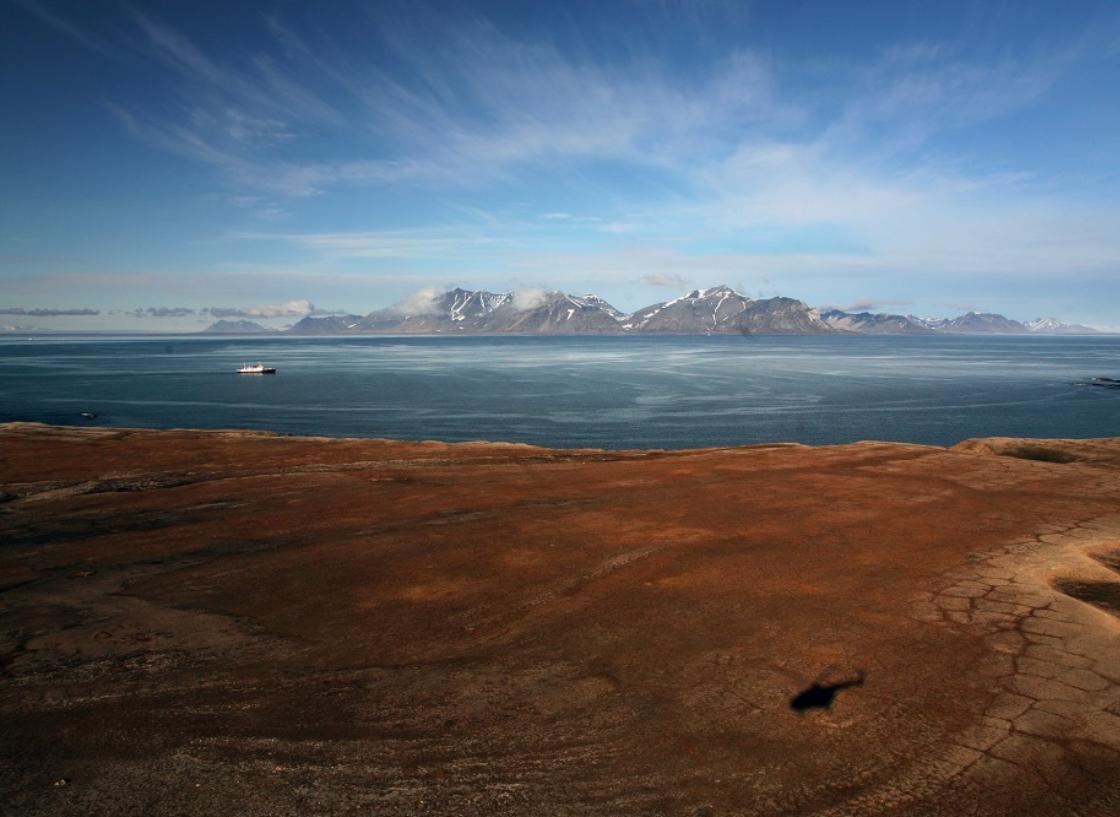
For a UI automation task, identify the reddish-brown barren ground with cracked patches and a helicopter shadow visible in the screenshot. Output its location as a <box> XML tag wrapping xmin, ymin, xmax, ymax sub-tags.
<box><xmin>0</xmin><ymin>424</ymin><xmax>1120</xmax><ymax>817</ymax></box>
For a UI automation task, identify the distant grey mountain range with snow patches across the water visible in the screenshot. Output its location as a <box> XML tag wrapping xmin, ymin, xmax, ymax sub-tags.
<box><xmin>206</xmin><ymin>286</ymin><xmax>1096</xmax><ymax>335</ymax></box>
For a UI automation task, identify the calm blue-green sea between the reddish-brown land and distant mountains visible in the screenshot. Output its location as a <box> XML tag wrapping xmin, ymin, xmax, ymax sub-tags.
<box><xmin>0</xmin><ymin>336</ymin><xmax>1120</xmax><ymax>448</ymax></box>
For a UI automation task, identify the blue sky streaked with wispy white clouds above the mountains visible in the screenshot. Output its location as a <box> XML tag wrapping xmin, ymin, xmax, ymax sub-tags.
<box><xmin>0</xmin><ymin>0</ymin><xmax>1120</xmax><ymax>331</ymax></box>
